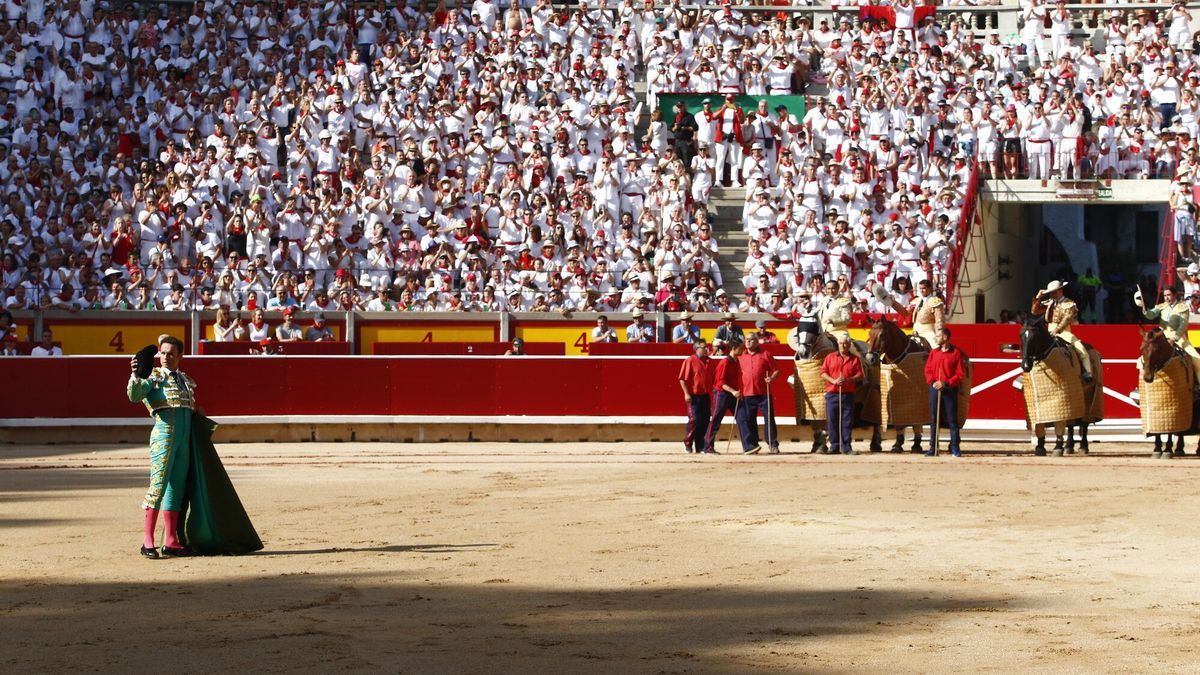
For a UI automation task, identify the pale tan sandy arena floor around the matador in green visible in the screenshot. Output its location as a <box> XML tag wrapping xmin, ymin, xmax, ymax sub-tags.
<box><xmin>0</xmin><ymin>443</ymin><xmax>1200</xmax><ymax>673</ymax></box>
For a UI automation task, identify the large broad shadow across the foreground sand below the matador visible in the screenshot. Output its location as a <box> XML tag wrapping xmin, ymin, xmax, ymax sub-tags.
<box><xmin>0</xmin><ymin>564</ymin><xmax>1024</xmax><ymax>673</ymax></box>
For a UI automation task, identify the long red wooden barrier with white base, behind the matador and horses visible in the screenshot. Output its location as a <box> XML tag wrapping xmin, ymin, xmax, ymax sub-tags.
<box><xmin>0</xmin><ymin>324</ymin><xmax>1139</xmax><ymax>420</ymax></box>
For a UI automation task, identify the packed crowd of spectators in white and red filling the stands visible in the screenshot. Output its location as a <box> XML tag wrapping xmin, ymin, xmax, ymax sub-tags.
<box><xmin>0</xmin><ymin>0</ymin><xmax>1200</xmax><ymax>329</ymax></box>
